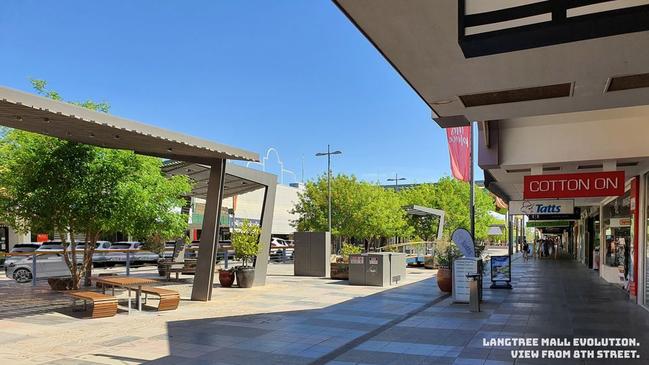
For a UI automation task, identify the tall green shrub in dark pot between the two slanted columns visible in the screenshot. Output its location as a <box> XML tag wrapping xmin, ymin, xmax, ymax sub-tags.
<box><xmin>232</xmin><ymin>219</ymin><xmax>261</xmax><ymax>288</ymax></box>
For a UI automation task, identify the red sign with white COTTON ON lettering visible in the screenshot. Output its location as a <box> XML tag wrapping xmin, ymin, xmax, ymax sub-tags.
<box><xmin>523</xmin><ymin>171</ymin><xmax>624</xmax><ymax>199</ymax></box>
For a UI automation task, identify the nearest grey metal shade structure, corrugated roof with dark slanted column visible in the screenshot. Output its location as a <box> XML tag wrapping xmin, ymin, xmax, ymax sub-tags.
<box><xmin>0</xmin><ymin>87</ymin><xmax>276</xmax><ymax>301</ymax></box>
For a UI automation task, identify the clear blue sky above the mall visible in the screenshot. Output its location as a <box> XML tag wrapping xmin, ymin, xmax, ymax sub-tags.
<box><xmin>0</xmin><ymin>0</ymin><xmax>482</xmax><ymax>183</ymax></box>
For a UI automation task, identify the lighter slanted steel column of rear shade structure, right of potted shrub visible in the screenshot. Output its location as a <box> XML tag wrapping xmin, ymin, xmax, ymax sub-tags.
<box><xmin>253</xmin><ymin>181</ymin><xmax>277</xmax><ymax>286</ymax></box>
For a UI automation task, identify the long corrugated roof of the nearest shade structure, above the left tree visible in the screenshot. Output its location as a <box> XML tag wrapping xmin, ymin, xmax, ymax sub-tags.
<box><xmin>0</xmin><ymin>87</ymin><xmax>259</xmax><ymax>164</ymax></box>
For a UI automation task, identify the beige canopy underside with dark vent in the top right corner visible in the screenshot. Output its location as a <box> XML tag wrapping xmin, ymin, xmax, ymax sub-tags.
<box><xmin>334</xmin><ymin>0</ymin><xmax>649</xmax><ymax>124</ymax></box>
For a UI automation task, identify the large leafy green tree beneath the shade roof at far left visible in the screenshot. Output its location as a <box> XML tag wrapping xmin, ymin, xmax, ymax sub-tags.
<box><xmin>0</xmin><ymin>80</ymin><xmax>191</xmax><ymax>288</ymax></box>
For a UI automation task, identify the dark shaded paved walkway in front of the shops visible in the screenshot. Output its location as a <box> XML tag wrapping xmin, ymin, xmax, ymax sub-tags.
<box><xmin>150</xmin><ymin>260</ymin><xmax>649</xmax><ymax>365</ymax></box>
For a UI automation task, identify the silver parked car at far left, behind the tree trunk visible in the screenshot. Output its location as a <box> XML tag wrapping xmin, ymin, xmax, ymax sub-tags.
<box><xmin>5</xmin><ymin>250</ymin><xmax>77</xmax><ymax>283</ymax></box>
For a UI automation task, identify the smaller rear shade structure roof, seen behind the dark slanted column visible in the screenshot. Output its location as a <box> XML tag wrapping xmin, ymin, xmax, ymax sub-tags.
<box><xmin>162</xmin><ymin>161</ymin><xmax>277</xmax><ymax>199</ymax></box>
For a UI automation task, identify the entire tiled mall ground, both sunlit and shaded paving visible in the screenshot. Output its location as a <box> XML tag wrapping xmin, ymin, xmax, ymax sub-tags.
<box><xmin>0</xmin><ymin>260</ymin><xmax>649</xmax><ymax>365</ymax></box>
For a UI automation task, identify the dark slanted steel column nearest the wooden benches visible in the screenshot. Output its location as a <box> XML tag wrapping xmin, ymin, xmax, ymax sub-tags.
<box><xmin>192</xmin><ymin>160</ymin><xmax>225</xmax><ymax>301</ymax></box>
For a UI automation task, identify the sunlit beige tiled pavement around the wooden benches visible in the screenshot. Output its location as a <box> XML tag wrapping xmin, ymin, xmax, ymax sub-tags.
<box><xmin>0</xmin><ymin>264</ymin><xmax>435</xmax><ymax>365</ymax></box>
